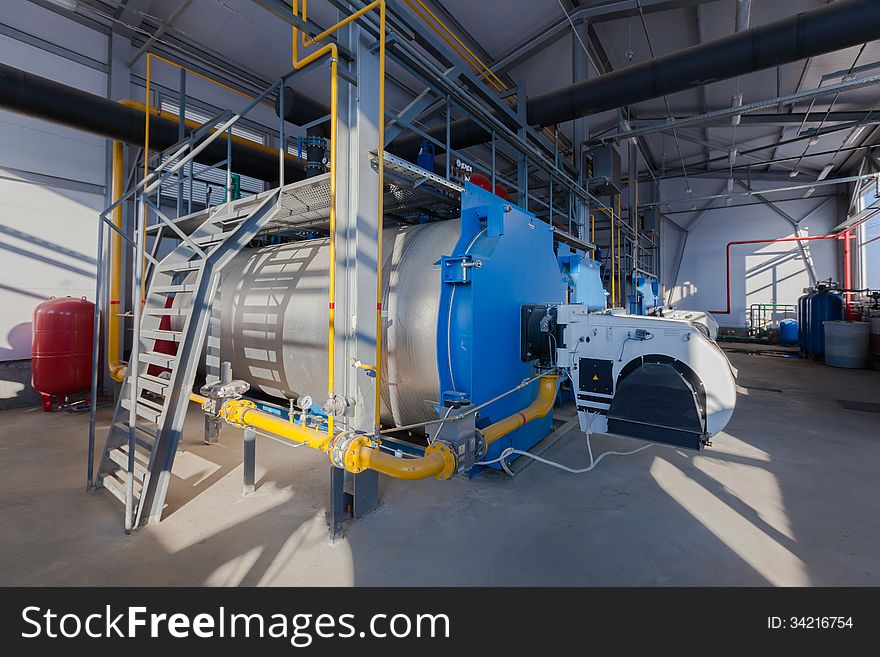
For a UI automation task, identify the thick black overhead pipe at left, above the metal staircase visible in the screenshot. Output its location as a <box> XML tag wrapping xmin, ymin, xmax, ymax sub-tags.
<box><xmin>0</xmin><ymin>64</ymin><xmax>305</xmax><ymax>182</ymax></box>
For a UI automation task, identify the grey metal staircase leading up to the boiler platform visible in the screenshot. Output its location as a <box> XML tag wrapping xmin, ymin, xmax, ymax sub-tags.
<box><xmin>96</xmin><ymin>189</ymin><xmax>281</xmax><ymax>530</ymax></box>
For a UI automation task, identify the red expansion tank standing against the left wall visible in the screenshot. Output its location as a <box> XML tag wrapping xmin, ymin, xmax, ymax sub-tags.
<box><xmin>31</xmin><ymin>297</ymin><xmax>95</xmax><ymax>411</ymax></box>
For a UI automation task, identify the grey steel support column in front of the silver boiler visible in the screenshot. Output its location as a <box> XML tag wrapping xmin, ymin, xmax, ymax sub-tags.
<box><xmin>329</xmin><ymin>16</ymin><xmax>380</xmax><ymax>536</ymax></box>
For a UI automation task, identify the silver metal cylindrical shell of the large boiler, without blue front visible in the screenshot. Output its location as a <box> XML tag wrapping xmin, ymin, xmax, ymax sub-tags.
<box><xmin>220</xmin><ymin>221</ymin><xmax>459</xmax><ymax>424</ymax></box>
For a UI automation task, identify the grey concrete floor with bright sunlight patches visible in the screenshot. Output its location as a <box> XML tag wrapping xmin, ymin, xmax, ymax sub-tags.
<box><xmin>0</xmin><ymin>345</ymin><xmax>880</xmax><ymax>586</ymax></box>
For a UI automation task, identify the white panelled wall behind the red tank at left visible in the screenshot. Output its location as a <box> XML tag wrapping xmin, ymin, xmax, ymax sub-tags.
<box><xmin>0</xmin><ymin>9</ymin><xmax>107</xmax><ymax>361</ymax></box>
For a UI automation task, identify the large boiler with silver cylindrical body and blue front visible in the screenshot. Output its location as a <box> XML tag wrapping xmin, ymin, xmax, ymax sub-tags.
<box><xmin>212</xmin><ymin>185</ymin><xmax>566</xmax><ymax>458</ymax></box>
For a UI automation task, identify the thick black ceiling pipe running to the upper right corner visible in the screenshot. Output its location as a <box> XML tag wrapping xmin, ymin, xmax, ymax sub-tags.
<box><xmin>389</xmin><ymin>0</ymin><xmax>880</xmax><ymax>158</ymax></box>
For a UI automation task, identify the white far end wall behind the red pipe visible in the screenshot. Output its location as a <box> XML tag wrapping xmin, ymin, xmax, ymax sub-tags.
<box><xmin>664</xmin><ymin>181</ymin><xmax>839</xmax><ymax>327</ymax></box>
